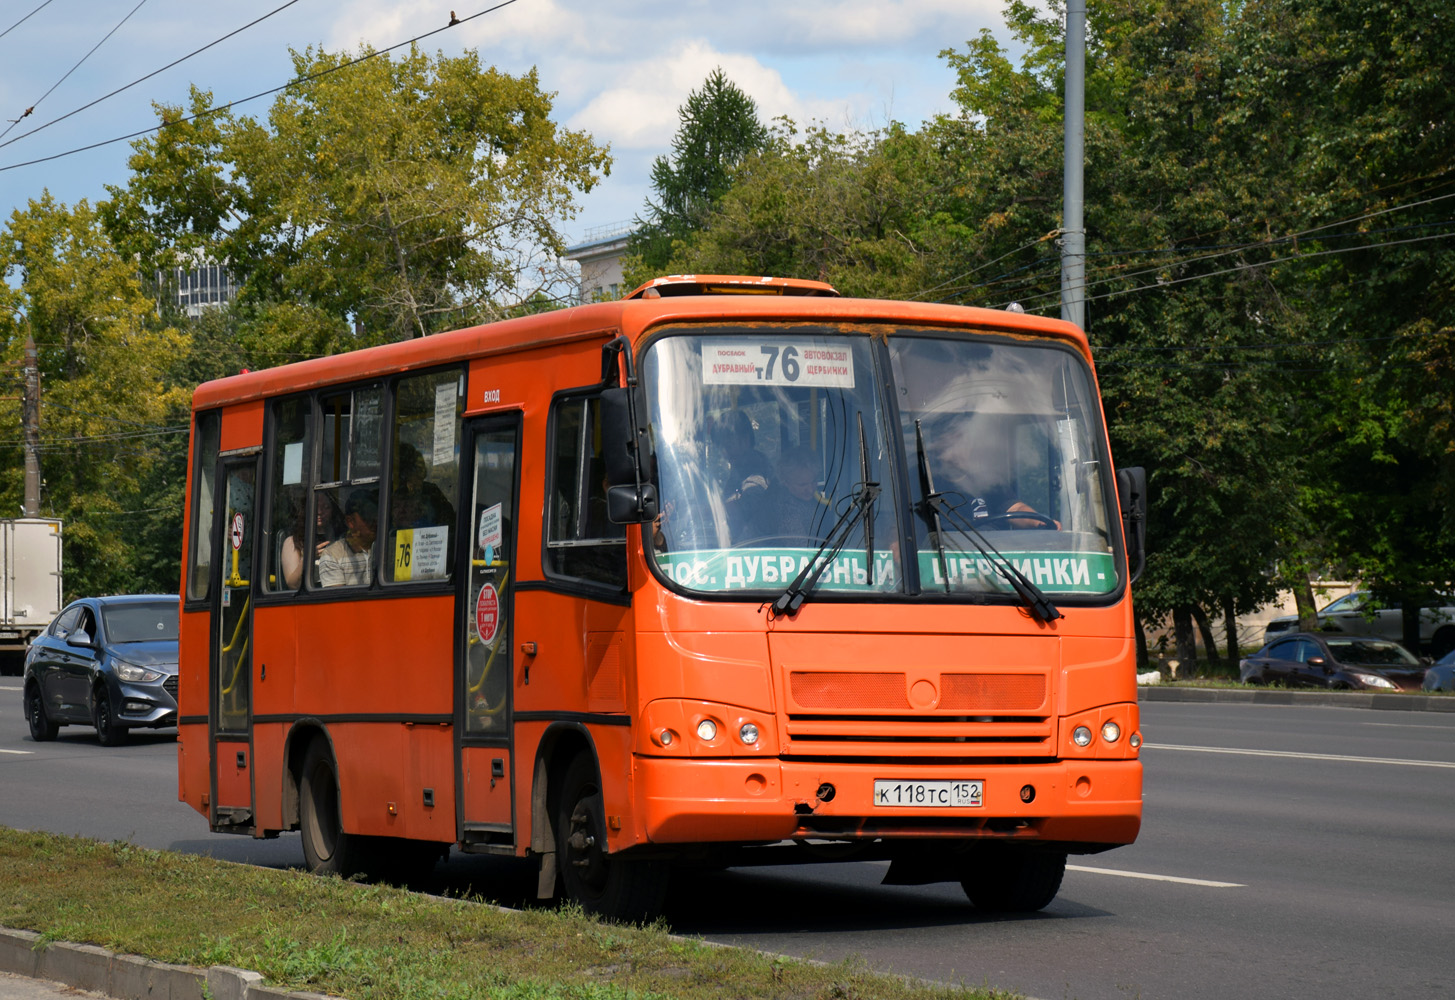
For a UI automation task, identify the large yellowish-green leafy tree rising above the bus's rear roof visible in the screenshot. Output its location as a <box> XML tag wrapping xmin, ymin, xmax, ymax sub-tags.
<box><xmin>108</xmin><ymin>48</ymin><xmax>610</xmax><ymax>348</ymax></box>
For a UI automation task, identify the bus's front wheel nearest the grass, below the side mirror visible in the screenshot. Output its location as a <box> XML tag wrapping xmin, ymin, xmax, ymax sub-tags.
<box><xmin>556</xmin><ymin>757</ymin><xmax>668</xmax><ymax>923</ymax></box>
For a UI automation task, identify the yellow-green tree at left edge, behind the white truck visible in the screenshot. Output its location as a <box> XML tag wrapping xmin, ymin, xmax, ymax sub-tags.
<box><xmin>0</xmin><ymin>194</ymin><xmax>189</xmax><ymax>597</ymax></box>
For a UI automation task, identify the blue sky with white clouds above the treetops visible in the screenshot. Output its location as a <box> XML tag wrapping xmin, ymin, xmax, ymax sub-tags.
<box><xmin>0</xmin><ymin>0</ymin><xmax>1008</xmax><ymax>243</ymax></box>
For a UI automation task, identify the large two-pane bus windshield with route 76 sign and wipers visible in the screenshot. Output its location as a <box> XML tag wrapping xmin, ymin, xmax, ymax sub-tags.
<box><xmin>642</xmin><ymin>325</ymin><xmax>1120</xmax><ymax>601</ymax></box>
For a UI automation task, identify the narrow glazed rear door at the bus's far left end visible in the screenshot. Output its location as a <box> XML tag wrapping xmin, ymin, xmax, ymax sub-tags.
<box><xmin>208</xmin><ymin>454</ymin><xmax>258</xmax><ymax>833</ymax></box>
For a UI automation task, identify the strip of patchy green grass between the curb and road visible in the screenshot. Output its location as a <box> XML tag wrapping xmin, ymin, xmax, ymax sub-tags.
<box><xmin>0</xmin><ymin>827</ymin><xmax>1017</xmax><ymax>1000</ymax></box>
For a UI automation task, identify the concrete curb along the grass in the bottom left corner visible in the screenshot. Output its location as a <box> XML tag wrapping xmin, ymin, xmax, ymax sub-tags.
<box><xmin>0</xmin><ymin>927</ymin><xmax>329</xmax><ymax>1000</ymax></box>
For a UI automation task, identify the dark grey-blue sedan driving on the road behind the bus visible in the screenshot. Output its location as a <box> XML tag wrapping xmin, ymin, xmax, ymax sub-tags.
<box><xmin>22</xmin><ymin>594</ymin><xmax>178</xmax><ymax>747</ymax></box>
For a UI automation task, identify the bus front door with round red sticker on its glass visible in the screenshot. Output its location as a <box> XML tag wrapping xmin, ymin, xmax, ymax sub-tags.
<box><xmin>455</xmin><ymin>415</ymin><xmax>519</xmax><ymax>853</ymax></box>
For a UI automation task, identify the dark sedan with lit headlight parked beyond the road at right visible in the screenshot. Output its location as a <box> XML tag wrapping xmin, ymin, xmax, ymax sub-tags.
<box><xmin>1238</xmin><ymin>632</ymin><xmax>1424</xmax><ymax>691</ymax></box>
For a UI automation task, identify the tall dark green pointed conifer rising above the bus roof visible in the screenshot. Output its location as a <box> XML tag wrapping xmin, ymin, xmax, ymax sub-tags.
<box><xmin>627</xmin><ymin>67</ymin><xmax>768</xmax><ymax>284</ymax></box>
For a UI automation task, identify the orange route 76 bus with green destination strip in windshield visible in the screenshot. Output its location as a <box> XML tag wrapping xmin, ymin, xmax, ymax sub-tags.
<box><xmin>178</xmin><ymin>277</ymin><xmax>1145</xmax><ymax>918</ymax></box>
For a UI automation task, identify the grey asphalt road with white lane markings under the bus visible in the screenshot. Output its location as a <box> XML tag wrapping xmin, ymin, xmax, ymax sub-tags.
<box><xmin>0</xmin><ymin>678</ymin><xmax>1455</xmax><ymax>1000</ymax></box>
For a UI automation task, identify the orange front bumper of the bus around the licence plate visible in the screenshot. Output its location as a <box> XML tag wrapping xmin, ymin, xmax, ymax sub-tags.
<box><xmin>634</xmin><ymin>755</ymin><xmax>1142</xmax><ymax>849</ymax></box>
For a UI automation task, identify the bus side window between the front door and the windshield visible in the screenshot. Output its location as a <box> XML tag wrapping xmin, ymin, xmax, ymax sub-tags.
<box><xmin>546</xmin><ymin>396</ymin><xmax>627</xmax><ymax>590</ymax></box>
